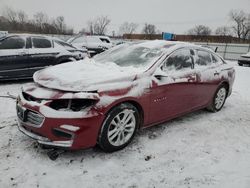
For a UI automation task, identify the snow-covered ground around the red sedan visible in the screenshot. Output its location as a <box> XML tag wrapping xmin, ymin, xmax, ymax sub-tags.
<box><xmin>0</xmin><ymin>62</ymin><xmax>250</xmax><ymax>188</ymax></box>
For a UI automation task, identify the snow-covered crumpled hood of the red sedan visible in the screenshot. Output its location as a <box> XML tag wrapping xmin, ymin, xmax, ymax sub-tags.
<box><xmin>33</xmin><ymin>58</ymin><xmax>142</xmax><ymax>92</ymax></box>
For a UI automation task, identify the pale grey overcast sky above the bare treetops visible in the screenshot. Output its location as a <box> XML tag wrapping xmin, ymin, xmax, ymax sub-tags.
<box><xmin>0</xmin><ymin>0</ymin><xmax>250</xmax><ymax>34</ymax></box>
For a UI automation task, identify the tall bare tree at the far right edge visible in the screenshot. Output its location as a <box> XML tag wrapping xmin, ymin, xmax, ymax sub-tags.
<box><xmin>229</xmin><ymin>10</ymin><xmax>250</xmax><ymax>39</ymax></box>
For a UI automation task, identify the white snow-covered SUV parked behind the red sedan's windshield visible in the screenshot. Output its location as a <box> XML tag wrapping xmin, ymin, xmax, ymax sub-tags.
<box><xmin>67</xmin><ymin>35</ymin><xmax>113</xmax><ymax>56</ymax></box>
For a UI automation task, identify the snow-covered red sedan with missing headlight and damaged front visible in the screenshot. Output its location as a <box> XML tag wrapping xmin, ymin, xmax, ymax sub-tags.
<box><xmin>17</xmin><ymin>40</ymin><xmax>235</xmax><ymax>152</ymax></box>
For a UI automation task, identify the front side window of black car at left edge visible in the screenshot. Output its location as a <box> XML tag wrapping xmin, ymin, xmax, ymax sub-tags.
<box><xmin>0</xmin><ymin>37</ymin><xmax>25</xmax><ymax>50</ymax></box>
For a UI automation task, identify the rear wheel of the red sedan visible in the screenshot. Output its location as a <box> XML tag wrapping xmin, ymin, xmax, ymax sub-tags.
<box><xmin>207</xmin><ymin>84</ymin><xmax>228</xmax><ymax>112</ymax></box>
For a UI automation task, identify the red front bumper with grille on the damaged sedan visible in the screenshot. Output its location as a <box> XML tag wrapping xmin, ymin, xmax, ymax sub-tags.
<box><xmin>16</xmin><ymin>83</ymin><xmax>104</xmax><ymax>150</ymax></box>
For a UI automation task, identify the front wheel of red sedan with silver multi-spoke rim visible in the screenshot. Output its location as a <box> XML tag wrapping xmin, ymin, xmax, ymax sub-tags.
<box><xmin>98</xmin><ymin>103</ymin><xmax>140</xmax><ymax>152</ymax></box>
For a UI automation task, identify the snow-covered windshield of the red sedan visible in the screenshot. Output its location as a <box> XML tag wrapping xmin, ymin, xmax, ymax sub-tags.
<box><xmin>94</xmin><ymin>41</ymin><xmax>172</xmax><ymax>68</ymax></box>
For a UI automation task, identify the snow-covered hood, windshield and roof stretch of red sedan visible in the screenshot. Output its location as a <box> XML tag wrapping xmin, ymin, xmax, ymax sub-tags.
<box><xmin>33</xmin><ymin>40</ymin><xmax>199</xmax><ymax>91</ymax></box>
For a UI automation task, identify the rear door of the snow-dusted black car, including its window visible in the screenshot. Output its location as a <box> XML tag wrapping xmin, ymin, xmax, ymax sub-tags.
<box><xmin>29</xmin><ymin>37</ymin><xmax>59</xmax><ymax>74</ymax></box>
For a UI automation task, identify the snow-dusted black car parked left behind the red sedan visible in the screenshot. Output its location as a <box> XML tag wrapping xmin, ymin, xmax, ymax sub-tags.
<box><xmin>0</xmin><ymin>35</ymin><xmax>87</xmax><ymax>80</ymax></box>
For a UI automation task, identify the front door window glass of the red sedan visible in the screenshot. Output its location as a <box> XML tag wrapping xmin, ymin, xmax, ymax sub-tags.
<box><xmin>162</xmin><ymin>49</ymin><xmax>193</xmax><ymax>72</ymax></box>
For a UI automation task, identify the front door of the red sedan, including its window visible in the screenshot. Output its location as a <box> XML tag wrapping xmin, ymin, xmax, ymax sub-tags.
<box><xmin>150</xmin><ymin>48</ymin><xmax>199</xmax><ymax>123</ymax></box>
